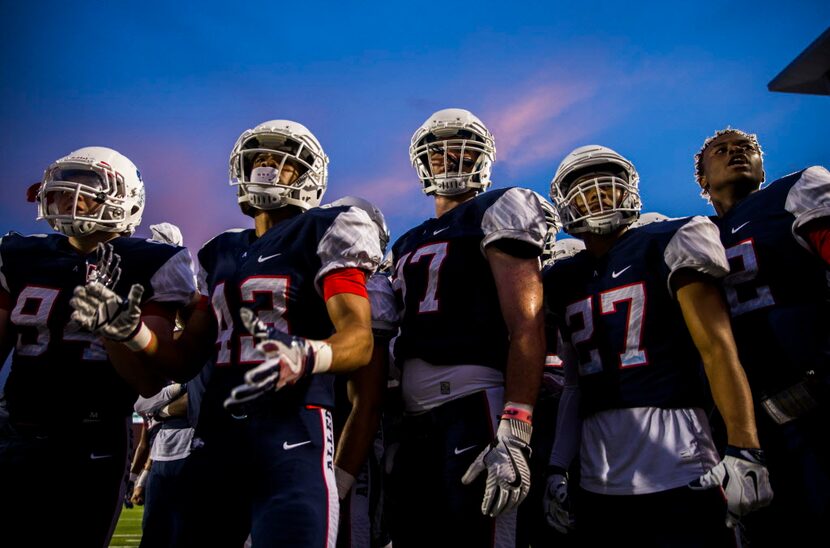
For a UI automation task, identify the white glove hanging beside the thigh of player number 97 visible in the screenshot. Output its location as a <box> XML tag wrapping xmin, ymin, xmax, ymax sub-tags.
<box><xmin>461</xmin><ymin>417</ymin><xmax>533</xmax><ymax>517</ymax></box>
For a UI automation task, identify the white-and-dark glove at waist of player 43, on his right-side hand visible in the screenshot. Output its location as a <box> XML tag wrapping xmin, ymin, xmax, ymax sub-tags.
<box><xmin>224</xmin><ymin>308</ymin><xmax>331</xmax><ymax>416</ymax></box>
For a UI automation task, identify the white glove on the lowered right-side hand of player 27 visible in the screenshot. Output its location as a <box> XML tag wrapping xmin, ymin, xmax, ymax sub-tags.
<box><xmin>689</xmin><ymin>445</ymin><xmax>772</xmax><ymax>528</ymax></box>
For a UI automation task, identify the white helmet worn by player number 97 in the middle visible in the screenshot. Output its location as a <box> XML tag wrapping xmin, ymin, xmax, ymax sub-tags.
<box><xmin>409</xmin><ymin>108</ymin><xmax>496</xmax><ymax>196</ymax></box>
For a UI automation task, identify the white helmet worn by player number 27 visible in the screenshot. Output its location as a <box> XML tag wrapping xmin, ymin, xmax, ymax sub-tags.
<box><xmin>550</xmin><ymin>145</ymin><xmax>642</xmax><ymax>234</ymax></box>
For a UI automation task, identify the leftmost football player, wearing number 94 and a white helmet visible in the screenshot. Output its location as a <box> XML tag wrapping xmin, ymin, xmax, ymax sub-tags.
<box><xmin>0</xmin><ymin>147</ymin><xmax>195</xmax><ymax>546</ymax></box>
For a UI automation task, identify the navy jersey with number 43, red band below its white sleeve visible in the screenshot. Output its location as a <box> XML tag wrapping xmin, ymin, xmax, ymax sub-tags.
<box><xmin>199</xmin><ymin>207</ymin><xmax>380</xmax><ymax>424</ymax></box>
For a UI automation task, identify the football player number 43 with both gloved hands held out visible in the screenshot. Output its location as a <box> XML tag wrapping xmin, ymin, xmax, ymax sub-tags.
<box><xmin>71</xmin><ymin>120</ymin><xmax>381</xmax><ymax>546</ymax></box>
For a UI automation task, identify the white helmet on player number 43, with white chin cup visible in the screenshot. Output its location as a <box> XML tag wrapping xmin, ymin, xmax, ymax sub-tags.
<box><xmin>228</xmin><ymin>120</ymin><xmax>329</xmax><ymax>211</ymax></box>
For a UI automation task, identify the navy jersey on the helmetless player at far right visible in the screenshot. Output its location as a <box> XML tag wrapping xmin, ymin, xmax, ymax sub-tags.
<box><xmin>716</xmin><ymin>167</ymin><xmax>830</xmax><ymax>395</ymax></box>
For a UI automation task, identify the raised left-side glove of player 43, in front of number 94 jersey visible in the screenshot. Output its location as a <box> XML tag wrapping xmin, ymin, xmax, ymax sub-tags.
<box><xmin>69</xmin><ymin>282</ymin><xmax>144</xmax><ymax>342</ymax></box>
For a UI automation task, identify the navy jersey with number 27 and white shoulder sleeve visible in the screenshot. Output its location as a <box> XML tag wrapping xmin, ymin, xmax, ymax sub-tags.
<box><xmin>544</xmin><ymin>217</ymin><xmax>727</xmax><ymax>416</ymax></box>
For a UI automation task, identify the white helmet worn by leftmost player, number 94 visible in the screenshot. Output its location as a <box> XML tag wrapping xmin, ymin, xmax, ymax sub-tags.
<box><xmin>37</xmin><ymin>147</ymin><xmax>144</xmax><ymax>236</ymax></box>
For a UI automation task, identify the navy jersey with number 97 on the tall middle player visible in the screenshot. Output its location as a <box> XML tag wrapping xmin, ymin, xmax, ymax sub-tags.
<box><xmin>392</xmin><ymin>188</ymin><xmax>547</xmax><ymax>370</ymax></box>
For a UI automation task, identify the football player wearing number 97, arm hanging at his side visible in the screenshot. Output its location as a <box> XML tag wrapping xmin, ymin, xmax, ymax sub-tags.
<box><xmin>392</xmin><ymin>109</ymin><xmax>547</xmax><ymax>547</ymax></box>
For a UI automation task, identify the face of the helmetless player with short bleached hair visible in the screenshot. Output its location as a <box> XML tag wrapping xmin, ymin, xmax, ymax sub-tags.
<box><xmin>703</xmin><ymin>133</ymin><xmax>764</xmax><ymax>194</ymax></box>
